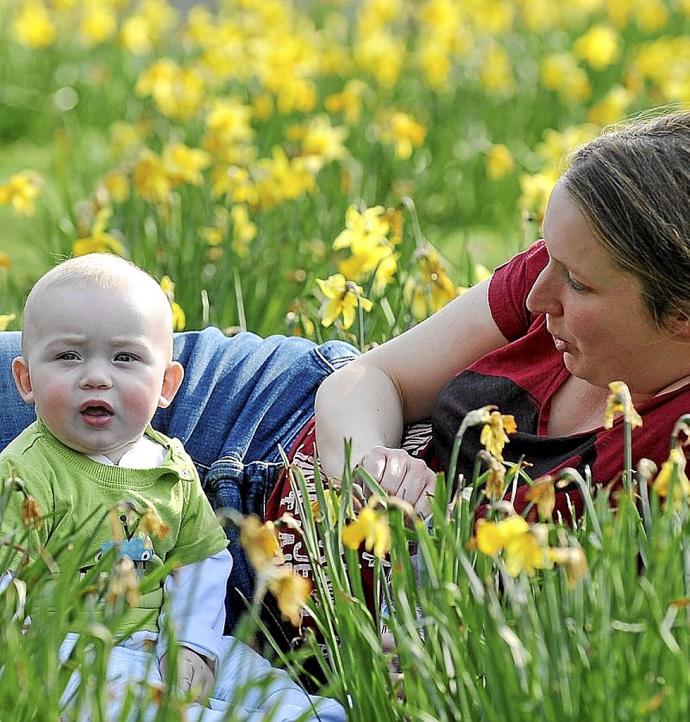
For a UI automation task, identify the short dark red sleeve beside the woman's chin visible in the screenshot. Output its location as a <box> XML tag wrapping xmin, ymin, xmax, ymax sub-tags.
<box><xmin>489</xmin><ymin>241</ymin><xmax>549</xmax><ymax>341</ymax></box>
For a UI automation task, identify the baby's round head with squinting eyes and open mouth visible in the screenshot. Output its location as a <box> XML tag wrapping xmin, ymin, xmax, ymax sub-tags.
<box><xmin>12</xmin><ymin>253</ymin><xmax>183</xmax><ymax>463</ymax></box>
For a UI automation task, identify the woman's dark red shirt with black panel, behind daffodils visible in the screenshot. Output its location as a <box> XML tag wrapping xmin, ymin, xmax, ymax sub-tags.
<box><xmin>432</xmin><ymin>241</ymin><xmax>690</xmax><ymax>513</ymax></box>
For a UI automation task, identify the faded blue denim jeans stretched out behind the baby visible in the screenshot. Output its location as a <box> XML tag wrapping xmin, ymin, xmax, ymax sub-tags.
<box><xmin>0</xmin><ymin>328</ymin><xmax>358</xmax><ymax>627</ymax></box>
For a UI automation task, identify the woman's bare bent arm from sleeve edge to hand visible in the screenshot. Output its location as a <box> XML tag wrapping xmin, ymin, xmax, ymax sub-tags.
<box><xmin>315</xmin><ymin>280</ymin><xmax>506</xmax><ymax>504</ymax></box>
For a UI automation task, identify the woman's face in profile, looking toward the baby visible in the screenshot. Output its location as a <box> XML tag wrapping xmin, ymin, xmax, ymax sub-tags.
<box><xmin>527</xmin><ymin>182</ymin><xmax>690</xmax><ymax>399</ymax></box>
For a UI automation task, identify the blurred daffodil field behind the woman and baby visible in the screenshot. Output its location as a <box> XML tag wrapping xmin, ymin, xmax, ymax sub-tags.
<box><xmin>0</xmin><ymin>0</ymin><xmax>690</xmax><ymax>346</ymax></box>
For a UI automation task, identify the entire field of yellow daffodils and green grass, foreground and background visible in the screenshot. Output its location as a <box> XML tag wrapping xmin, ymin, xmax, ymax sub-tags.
<box><xmin>0</xmin><ymin>0</ymin><xmax>690</xmax><ymax>722</ymax></box>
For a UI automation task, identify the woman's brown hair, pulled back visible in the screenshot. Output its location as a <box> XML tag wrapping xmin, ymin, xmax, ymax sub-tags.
<box><xmin>563</xmin><ymin>112</ymin><xmax>690</xmax><ymax>326</ymax></box>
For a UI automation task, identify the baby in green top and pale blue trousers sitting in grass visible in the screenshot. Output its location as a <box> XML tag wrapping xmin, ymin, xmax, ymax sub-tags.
<box><xmin>0</xmin><ymin>254</ymin><xmax>344</xmax><ymax>720</ymax></box>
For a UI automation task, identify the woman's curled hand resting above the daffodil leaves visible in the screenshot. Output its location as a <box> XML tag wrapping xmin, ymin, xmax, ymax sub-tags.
<box><xmin>359</xmin><ymin>446</ymin><xmax>436</xmax><ymax>516</ymax></box>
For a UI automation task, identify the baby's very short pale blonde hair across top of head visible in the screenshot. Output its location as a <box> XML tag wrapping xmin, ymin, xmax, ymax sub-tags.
<box><xmin>22</xmin><ymin>253</ymin><xmax>173</xmax><ymax>356</ymax></box>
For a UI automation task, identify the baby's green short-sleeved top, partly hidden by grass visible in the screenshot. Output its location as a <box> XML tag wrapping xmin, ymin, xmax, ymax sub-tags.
<box><xmin>0</xmin><ymin>419</ymin><xmax>227</xmax><ymax>634</ymax></box>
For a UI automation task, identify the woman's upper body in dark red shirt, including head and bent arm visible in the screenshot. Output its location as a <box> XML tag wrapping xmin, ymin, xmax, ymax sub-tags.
<box><xmin>316</xmin><ymin>112</ymin><xmax>690</xmax><ymax>513</ymax></box>
